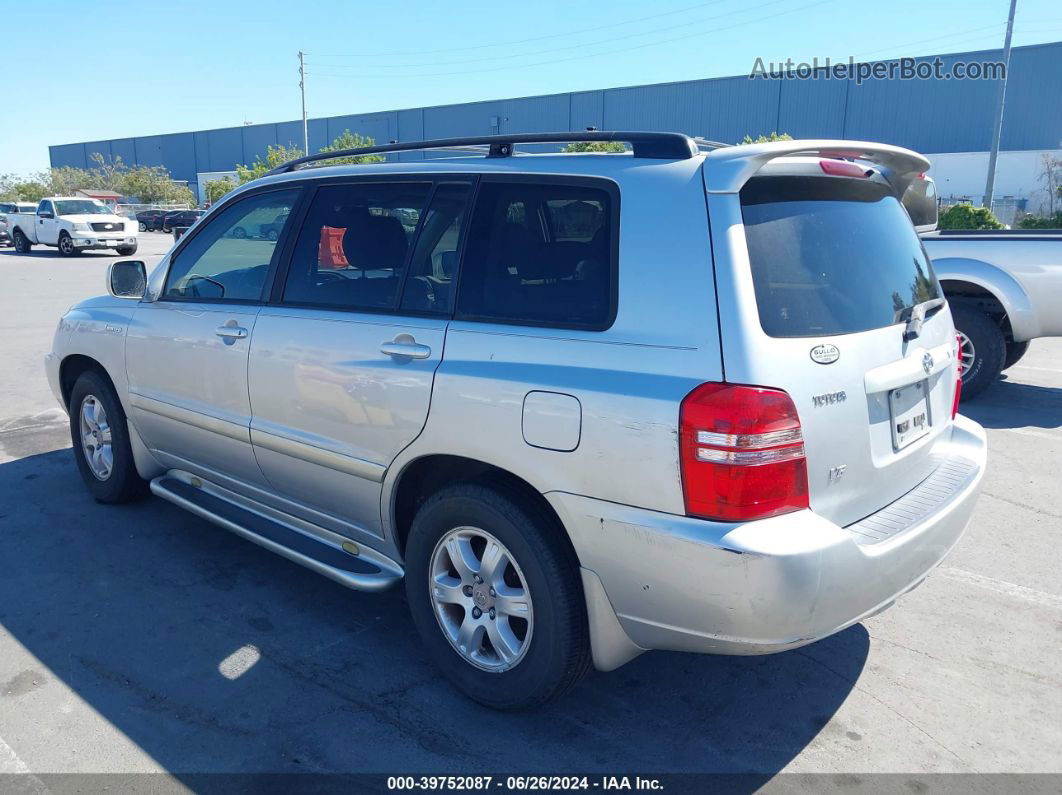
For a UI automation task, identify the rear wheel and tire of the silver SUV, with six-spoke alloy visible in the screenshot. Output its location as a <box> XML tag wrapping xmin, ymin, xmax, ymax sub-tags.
<box><xmin>406</xmin><ymin>484</ymin><xmax>590</xmax><ymax>710</ymax></box>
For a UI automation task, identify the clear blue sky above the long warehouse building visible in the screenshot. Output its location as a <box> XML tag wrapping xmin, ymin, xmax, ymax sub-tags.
<box><xmin>0</xmin><ymin>0</ymin><xmax>1062</xmax><ymax>174</ymax></box>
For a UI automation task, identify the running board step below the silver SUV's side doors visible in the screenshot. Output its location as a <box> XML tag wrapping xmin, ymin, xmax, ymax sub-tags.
<box><xmin>151</xmin><ymin>470</ymin><xmax>402</xmax><ymax>591</ymax></box>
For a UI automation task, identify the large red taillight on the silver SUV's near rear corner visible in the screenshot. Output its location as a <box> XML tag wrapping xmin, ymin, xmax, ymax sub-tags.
<box><xmin>679</xmin><ymin>383</ymin><xmax>808</xmax><ymax>521</ymax></box>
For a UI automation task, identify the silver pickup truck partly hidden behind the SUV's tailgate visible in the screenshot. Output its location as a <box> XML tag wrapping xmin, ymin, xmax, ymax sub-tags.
<box><xmin>922</xmin><ymin>229</ymin><xmax>1062</xmax><ymax>398</ymax></box>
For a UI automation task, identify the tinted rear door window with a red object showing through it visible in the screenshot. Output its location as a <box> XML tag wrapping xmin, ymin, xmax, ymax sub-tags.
<box><xmin>284</xmin><ymin>183</ymin><xmax>431</xmax><ymax>310</ymax></box>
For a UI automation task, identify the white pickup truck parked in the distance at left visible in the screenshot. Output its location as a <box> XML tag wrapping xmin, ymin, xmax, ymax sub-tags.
<box><xmin>7</xmin><ymin>196</ymin><xmax>137</xmax><ymax>257</ymax></box>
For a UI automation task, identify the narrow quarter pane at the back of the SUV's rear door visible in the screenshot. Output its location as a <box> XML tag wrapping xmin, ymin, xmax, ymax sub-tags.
<box><xmin>401</xmin><ymin>184</ymin><xmax>472</xmax><ymax>314</ymax></box>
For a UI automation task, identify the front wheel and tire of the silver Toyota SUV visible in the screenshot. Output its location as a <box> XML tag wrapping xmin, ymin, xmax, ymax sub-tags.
<box><xmin>69</xmin><ymin>370</ymin><xmax>148</xmax><ymax>504</ymax></box>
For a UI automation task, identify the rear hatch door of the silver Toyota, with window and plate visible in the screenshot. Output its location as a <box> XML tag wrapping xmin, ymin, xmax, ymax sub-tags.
<box><xmin>709</xmin><ymin>162</ymin><xmax>957</xmax><ymax>525</ymax></box>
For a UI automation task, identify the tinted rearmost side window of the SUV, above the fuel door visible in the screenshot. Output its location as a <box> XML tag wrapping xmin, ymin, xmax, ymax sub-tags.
<box><xmin>458</xmin><ymin>182</ymin><xmax>616</xmax><ymax>329</ymax></box>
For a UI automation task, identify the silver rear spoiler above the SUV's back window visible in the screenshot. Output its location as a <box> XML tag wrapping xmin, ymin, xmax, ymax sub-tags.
<box><xmin>704</xmin><ymin>140</ymin><xmax>929</xmax><ymax>196</ymax></box>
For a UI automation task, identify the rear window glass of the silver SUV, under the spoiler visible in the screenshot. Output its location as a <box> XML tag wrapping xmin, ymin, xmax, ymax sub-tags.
<box><xmin>741</xmin><ymin>176</ymin><xmax>941</xmax><ymax>336</ymax></box>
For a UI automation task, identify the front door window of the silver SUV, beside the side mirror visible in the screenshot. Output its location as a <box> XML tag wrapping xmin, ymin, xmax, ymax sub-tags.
<box><xmin>162</xmin><ymin>190</ymin><xmax>298</xmax><ymax>300</ymax></box>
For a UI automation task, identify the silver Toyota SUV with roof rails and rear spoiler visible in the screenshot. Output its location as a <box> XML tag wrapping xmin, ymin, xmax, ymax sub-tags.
<box><xmin>47</xmin><ymin>132</ymin><xmax>986</xmax><ymax>708</ymax></box>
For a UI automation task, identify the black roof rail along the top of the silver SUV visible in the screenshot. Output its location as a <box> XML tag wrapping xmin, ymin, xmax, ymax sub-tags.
<box><xmin>266</xmin><ymin>131</ymin><xmax>699</xmax><ymax>176</ymax></box>
